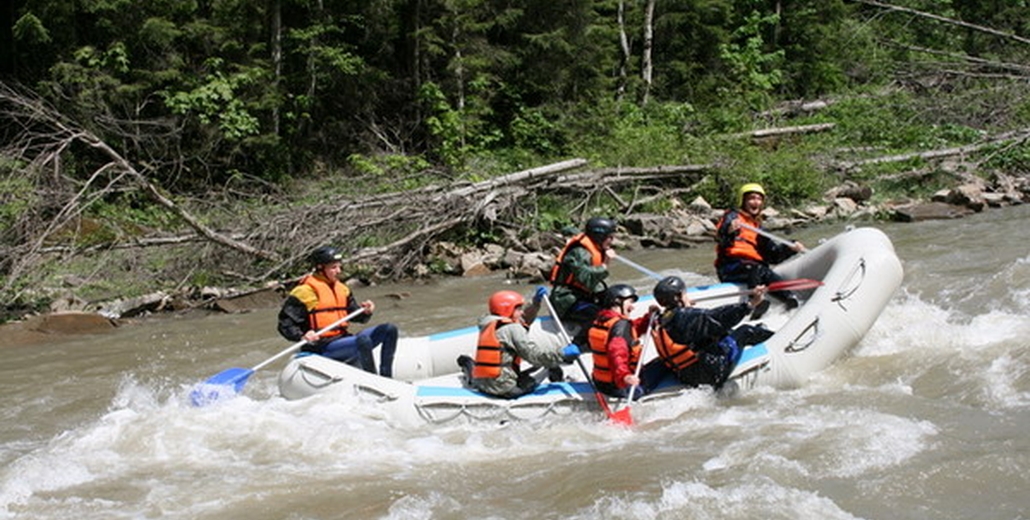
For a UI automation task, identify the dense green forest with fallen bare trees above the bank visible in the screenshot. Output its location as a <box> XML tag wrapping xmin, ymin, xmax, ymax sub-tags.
<box><xmin>0</xmin><ymin>0</ymin><xmax>1030</xmax><ymax>319</ymax></box>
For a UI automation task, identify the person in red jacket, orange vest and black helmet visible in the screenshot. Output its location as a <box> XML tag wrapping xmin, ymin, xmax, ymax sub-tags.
<box><xmin>587</xmin><ymin>283</ymin><xmax>658</xmax><ymax>398</ymax></box>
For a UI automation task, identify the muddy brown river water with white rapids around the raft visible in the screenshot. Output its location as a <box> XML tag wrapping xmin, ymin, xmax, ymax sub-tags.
<box><xmin>0</xmin><ymin>205</ymin><xmax>1030</xmax><ymax>520</ymax></box>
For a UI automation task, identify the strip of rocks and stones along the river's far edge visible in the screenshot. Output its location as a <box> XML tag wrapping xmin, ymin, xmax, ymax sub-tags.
<box><xmin>4</xmin><ymin>176</ymin><xmax>1030</xmax><ymax>344</ymax></box>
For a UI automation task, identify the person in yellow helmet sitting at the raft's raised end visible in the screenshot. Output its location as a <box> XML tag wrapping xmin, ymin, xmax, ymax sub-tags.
<box><xmin>715</xmin><ymin>182</ymin><xmax>804</xmax><ymax>310</ymax></box>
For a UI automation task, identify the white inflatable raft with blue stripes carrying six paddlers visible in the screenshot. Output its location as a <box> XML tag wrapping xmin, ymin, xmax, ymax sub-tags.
<box><xmin>279</xmin><ymin>228</ymin><xmax>902</xmax><ymax>423</ymax></box>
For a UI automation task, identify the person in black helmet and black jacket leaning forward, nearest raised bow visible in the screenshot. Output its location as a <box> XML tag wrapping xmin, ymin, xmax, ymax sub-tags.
<box><xmin>641</xmin><ymin>276</ymin><xmax>773</xmax><ymax>391</ymax></box>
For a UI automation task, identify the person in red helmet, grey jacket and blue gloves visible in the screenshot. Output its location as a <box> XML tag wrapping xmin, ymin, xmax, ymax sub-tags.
<box><xmin>458</xmin><ymin>290</ymin><xmax>579</xmax><ymax>398</ymax></box>
